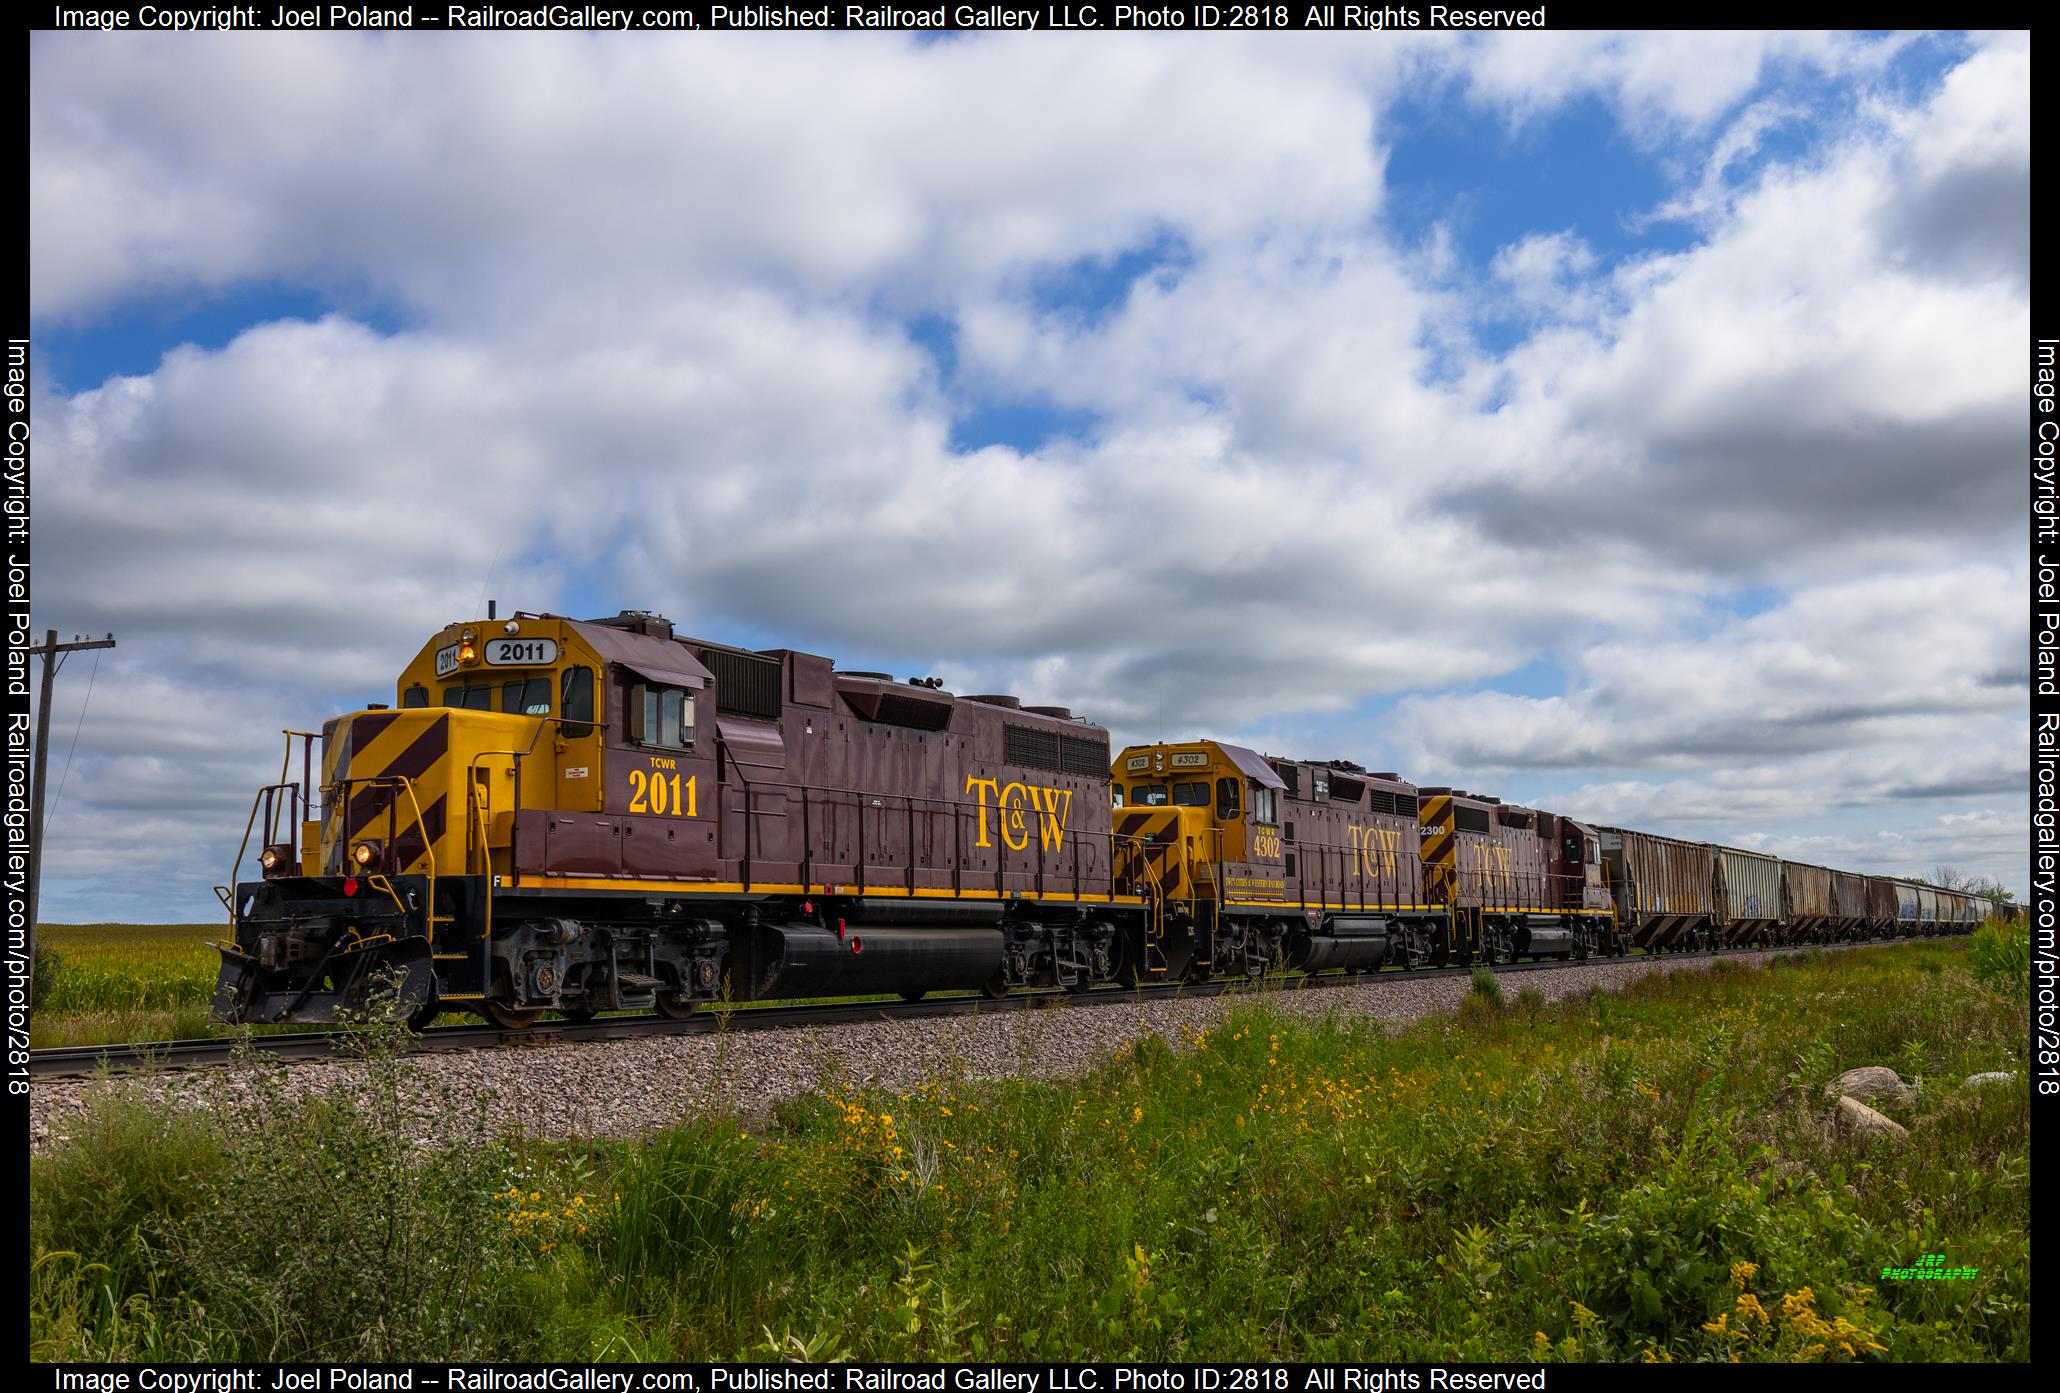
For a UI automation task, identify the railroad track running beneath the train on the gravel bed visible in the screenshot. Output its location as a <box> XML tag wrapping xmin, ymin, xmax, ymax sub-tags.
<box><xmin>29</xmin><ymin>940</ymin><xmax>1926</xmax><ymax>1078</ymax></box>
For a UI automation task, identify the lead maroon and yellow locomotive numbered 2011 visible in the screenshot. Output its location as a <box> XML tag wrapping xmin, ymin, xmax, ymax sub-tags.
<box><xmin>214</xmin><ymin>612</ymin><xmax>1143</xmax><ymax>1026</ymax></box>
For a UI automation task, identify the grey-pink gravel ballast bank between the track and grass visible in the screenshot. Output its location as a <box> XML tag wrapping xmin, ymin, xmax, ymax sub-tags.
<box><xmin>29</xmin><ymin>956</ymin><xmax>1753</xmax><ymax>1150</ymax></box>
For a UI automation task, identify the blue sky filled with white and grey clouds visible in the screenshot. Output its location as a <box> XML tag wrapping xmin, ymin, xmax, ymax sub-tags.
<box><xmin>29</xmin><ymin>31</ymin><xmax>2031</xmax><ymax>921</ymax></box>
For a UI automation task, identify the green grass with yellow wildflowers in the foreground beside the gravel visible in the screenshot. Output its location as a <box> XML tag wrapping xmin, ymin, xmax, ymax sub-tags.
<box><xmin>29</xmin><ymin>942</ymin><xmax>2031</xmax><ymax>1360</ymax></box>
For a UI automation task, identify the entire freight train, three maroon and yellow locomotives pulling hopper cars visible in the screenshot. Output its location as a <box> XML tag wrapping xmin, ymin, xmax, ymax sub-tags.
<box><xmin>214</xmin><ymin>610</ymin><xmax>1986</xmax><ymax>1026</ymax></box>
